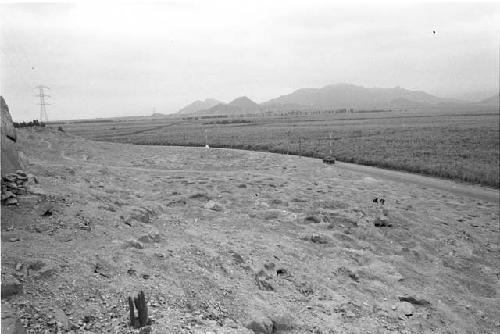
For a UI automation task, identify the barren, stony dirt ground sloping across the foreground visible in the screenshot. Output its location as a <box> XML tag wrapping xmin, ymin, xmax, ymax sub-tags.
<box><xmin>1</xmin><ymin>129</ymin><xmax>500</xmax><ymax>333</ymax></box>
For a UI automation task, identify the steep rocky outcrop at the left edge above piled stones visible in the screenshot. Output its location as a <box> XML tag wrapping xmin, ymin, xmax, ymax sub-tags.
<box><xmin>0</xmin><ymin>96</ymin><xmax>22</xmax><ymax>176</ymax></box>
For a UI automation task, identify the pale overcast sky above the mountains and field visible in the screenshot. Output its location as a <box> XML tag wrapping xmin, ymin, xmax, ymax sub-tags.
<box><xmin>0</xmin><ymin>0</ymin><xmax>500</xmax><ymax>120</ymax></box>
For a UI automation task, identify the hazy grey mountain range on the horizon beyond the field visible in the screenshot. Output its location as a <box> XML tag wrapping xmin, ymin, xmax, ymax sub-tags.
<box><xmin>179</xmin><ymin>84</ymin><xmax>499</xmax><ymax>115</ymax></box>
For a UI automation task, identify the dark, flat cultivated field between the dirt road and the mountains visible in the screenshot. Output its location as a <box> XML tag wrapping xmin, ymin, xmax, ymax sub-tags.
<box><xmin>59</xmin><ymin>110</ymin><xmax>499</xmax><ymax>188</ymax></box>
